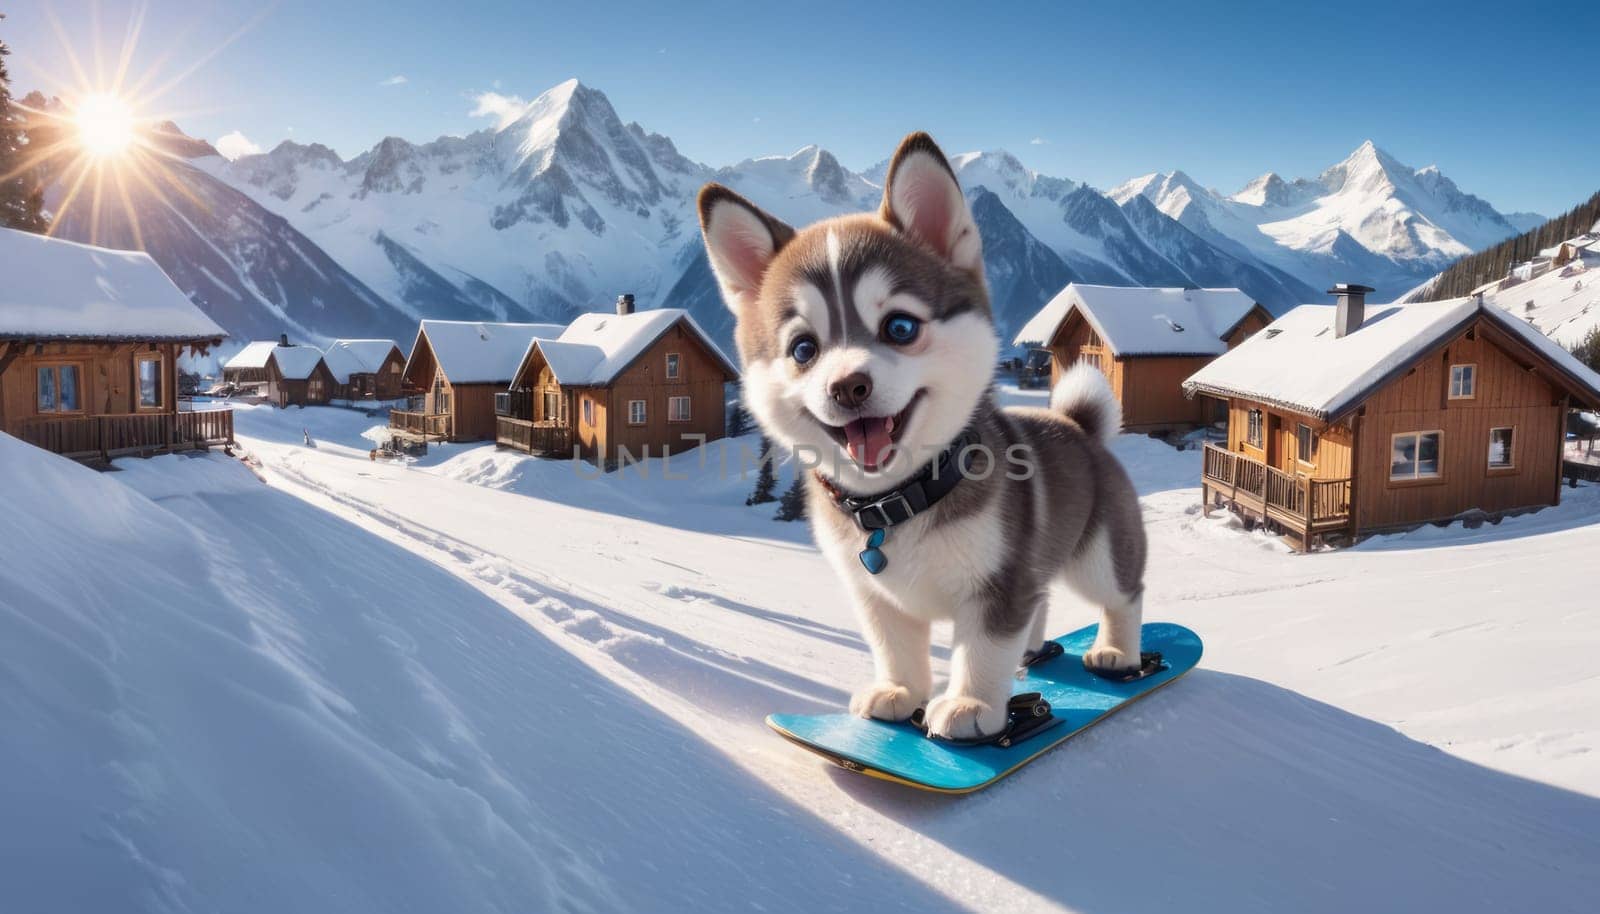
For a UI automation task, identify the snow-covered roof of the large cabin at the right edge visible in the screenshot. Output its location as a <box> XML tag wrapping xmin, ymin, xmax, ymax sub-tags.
<box><xmin>1184</xmin><ymin>298</ymin><xmax>1600</xmax><ymax>419</ymax></box>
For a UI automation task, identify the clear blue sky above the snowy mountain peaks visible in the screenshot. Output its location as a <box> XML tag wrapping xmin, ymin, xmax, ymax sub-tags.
<box><xmin>0</xmin><ymin>0</ymin><xmax>1600</xmax><ymax>214</ymax></box>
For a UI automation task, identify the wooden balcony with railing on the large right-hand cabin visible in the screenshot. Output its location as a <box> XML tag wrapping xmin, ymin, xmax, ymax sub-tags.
<box><xmin>1200</xmin><ymin>443</ymin><xmax>1350</xmax><ymax>551</ymax></box>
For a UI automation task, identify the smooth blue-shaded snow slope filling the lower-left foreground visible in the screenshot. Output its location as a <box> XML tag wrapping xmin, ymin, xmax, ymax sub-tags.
<box><xmin>0</xmin><ymin>432</ymin><xmax>957</xmax><ymax>914</ymax></box>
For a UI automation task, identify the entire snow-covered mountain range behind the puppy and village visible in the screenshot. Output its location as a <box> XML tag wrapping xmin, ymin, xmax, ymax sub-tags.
<box><xmin>28</xmin><ymin>80</ymin><xmax>1525</xmax><ymax>350</ymax></box>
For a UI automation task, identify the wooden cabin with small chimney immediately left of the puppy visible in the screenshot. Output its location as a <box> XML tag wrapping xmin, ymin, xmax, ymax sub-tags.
<box><xmin>494</xmin><ymin>296</ymin><xmax>739</xmax><ymax>466</ymax></box>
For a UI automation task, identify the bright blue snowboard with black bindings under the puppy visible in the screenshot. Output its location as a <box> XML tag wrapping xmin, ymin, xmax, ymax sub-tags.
<box><xmin>766</xmin><ymin>623</ymin><xmax>1202</xmax><ymax>794</ymax></box>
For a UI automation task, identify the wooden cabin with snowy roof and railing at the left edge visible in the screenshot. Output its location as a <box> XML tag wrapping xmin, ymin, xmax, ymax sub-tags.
<box><xmin>0</xmin><ymin>229</ymin><xmax>234</xmax><ymax>461</ymax></box>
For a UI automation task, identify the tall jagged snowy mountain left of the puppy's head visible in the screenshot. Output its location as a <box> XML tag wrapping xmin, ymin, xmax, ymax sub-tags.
<box><xmin>206</xmin><ymin>80</ymin><xmax>709</xmax><ymax>329</ymax></box>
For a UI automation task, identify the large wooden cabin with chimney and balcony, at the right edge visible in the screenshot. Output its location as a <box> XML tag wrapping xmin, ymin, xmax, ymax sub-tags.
<box><xmin>1184</xmin><ymin>287</ymin><xmax>1600</xmax><ymax>549</ymax></box>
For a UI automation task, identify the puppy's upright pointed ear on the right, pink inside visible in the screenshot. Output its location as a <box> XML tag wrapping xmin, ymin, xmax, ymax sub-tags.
<box><xmin>880</xmin><ymin>133</ymin><xmax>984</xmax><ymax>279</ymax></box>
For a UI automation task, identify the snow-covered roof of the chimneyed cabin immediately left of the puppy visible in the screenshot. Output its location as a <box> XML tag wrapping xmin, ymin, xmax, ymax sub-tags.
<box><xmin>525</xmin><ymin>307</ymin><xmax>739</xmax><ymax>386</ymax></box>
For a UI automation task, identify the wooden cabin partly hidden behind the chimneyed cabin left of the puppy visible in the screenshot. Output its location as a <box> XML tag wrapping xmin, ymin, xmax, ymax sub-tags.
<box><xmin>389</xmin><ymin>320</ymin><xmax>565</xmax><ymax>442</ymax></box>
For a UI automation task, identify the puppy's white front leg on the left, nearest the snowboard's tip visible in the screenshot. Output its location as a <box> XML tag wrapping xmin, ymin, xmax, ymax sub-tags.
<box><xmin>850</xmin><ymin>592</ymin><xmax>933</xmax><ymax>720</ymax></box>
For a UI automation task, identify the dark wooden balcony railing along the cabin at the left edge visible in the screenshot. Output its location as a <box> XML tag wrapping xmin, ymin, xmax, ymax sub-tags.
<box><xmin>13</xmin><ymin>410</ymin><xmax>234</xmax><ymax>459</ymax></box>
